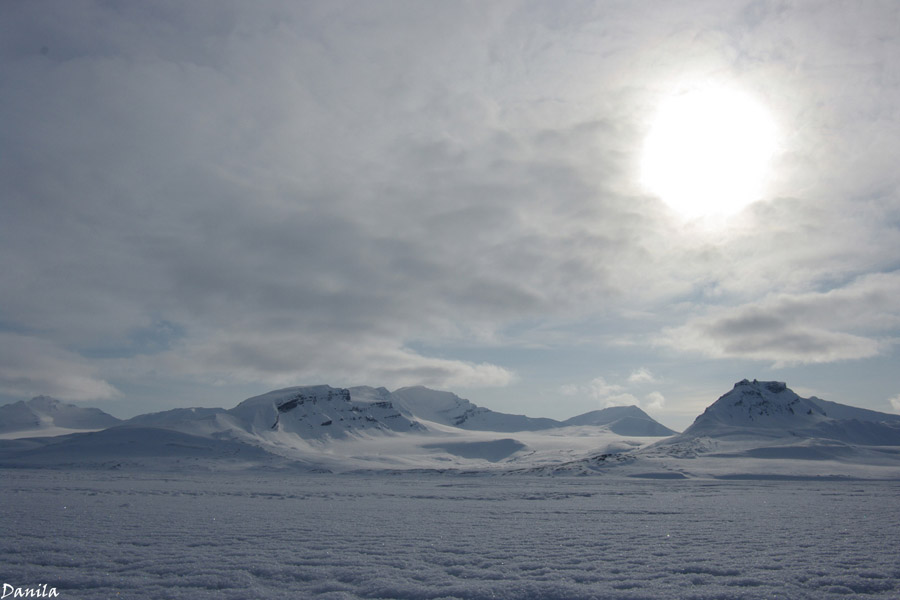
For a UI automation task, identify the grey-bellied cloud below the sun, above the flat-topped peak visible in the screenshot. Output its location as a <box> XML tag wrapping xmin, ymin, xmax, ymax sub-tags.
<box><xmin>659</xmin><ymin>272</ymin><xmax>900</xmax><ymax>367</ymax></box>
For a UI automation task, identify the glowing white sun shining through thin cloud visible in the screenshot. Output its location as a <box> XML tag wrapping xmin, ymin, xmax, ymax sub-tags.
<box><xmin>641</xmin><ymin>86</ymin><xmax>776</xmax><ymax>219</ymax></box>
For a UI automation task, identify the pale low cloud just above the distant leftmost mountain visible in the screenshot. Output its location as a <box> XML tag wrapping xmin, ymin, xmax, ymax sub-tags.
<box><xmin>0</xmin><ymin>333</ymin><xmax>119</xmax><ymax>400</ymax></box>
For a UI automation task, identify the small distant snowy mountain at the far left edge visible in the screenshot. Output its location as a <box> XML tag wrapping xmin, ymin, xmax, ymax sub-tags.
<box><xmin>0</xmin><ymin>396</ymin><xmax>120</xmax><ymax>436</ymax></box>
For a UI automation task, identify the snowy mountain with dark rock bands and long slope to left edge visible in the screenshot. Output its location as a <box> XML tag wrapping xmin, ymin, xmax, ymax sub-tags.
<box><xmin>0</xmin><ymin>385</ymin><xmax>425</xmax><ymax>470</ymax></box>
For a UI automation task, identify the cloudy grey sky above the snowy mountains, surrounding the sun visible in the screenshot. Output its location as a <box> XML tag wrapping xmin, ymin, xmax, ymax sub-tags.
<box><xmin>0</xmin><ymin>0</ymin><xmax>900</xmax><ymax>429</ymax></box>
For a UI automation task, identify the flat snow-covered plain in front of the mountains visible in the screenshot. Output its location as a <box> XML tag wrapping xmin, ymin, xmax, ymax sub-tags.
<box><xmin>0</xmin><ymin>469</ymin><xmax>900</xmax><ymax>600</ymax></box>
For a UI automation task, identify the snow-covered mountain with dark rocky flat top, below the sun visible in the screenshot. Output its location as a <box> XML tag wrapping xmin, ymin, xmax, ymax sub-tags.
<box><xmin>531</xmin><ymin>379</ymin><xmax>900</xmax><ymax>479</ymax></box>
